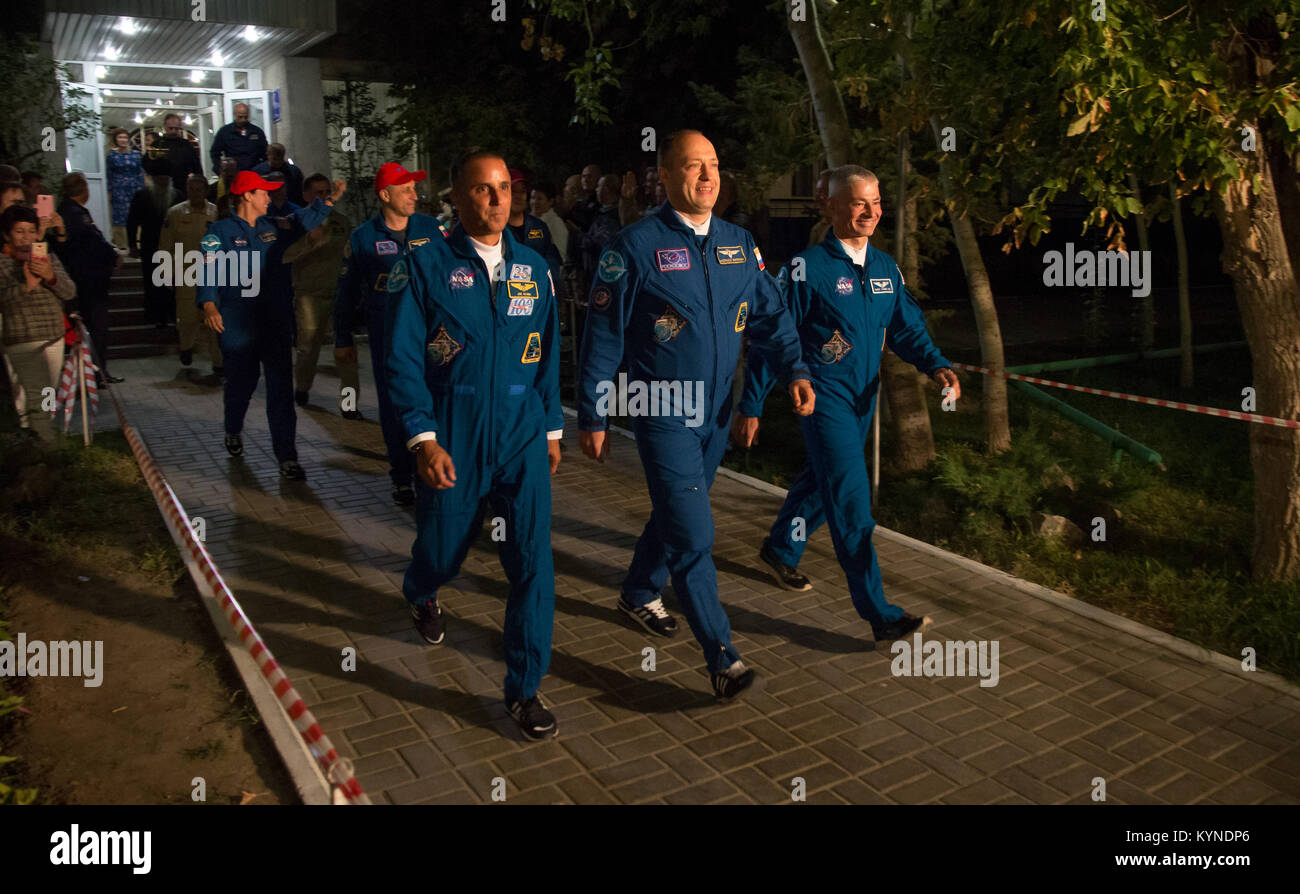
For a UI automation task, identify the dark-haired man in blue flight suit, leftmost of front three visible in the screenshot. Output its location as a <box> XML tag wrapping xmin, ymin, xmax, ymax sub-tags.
<box><xmin>386</xmin><ymin>147</ymin><xmax>564</xmax><ymax>739</ymax></box>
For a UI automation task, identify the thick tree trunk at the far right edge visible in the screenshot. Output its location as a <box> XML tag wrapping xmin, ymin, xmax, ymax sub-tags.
<box><xmin>1214</xmin><ymin>142</ymin><xmax>1300</xmax><ymax>580</ymax></box>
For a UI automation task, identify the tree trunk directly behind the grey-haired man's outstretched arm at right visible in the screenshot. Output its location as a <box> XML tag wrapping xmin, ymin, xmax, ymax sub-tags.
<box><xmin>880</xmin><ymin>131</ymin><xmax>935</xmax><ymax>472</ymax></box>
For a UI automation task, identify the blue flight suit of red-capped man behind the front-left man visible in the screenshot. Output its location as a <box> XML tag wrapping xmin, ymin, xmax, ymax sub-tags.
<box><xmin>334</xmin><ymin>212</ymin><xmax>447</xmax><ymax>485</ymax></box>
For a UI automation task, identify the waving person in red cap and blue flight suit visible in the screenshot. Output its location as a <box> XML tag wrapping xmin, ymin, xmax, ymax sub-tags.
<box><xmin>194</xmin><ymin>170</ymin><xmax>347</xmax><ymax>481</ymax></box>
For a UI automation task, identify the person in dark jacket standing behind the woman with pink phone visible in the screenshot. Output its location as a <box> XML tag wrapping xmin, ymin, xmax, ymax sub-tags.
<box><xmin>51</xmin><ymin>173</ymin><xmax>124</xmax><ymax>386</ymax></box>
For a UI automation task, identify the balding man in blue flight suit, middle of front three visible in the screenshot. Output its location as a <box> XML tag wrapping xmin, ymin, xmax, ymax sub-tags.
<box><xmin>579</xmin><ymin>130</ymin><xmax>814</xmax><ymax>700</ymax></box>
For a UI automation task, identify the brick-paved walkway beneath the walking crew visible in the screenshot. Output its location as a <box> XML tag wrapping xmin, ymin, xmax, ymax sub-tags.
<box><xmin>100</xmin><ymin>348</ymin><xmax>1300</xmax><ymax>804</ymax></box>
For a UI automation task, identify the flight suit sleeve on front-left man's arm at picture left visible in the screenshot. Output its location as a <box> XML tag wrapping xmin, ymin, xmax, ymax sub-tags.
<box><xmin>384</xmin><ymin>255</ymin><xmax>442</xmax><ymax>442</ymax></box>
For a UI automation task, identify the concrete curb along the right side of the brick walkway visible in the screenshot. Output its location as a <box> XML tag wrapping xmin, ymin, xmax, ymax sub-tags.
<box><xmin>564</xmin><ymin>407</ymin><xmax>1300</xmax><ymax>699</ymax></box>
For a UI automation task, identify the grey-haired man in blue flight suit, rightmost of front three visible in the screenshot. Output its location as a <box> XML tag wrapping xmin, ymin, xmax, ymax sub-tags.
<box><xmin>733</xmin><ymin>165</ymin><xmax>962</xmax><ymax>641</ymax></box>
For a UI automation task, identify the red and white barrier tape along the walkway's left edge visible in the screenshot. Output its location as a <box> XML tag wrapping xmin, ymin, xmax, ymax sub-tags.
<box><xmin>97</xmin><ymin>356</ymin><xmax>371</xmax><ymax>804</ymax></box>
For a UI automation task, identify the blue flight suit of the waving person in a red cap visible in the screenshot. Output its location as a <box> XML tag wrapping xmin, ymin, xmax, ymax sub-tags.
<box><xmin>194</xmin><ymin>199</ymin><xmax>330</xmax><ymax>463</ymax></box>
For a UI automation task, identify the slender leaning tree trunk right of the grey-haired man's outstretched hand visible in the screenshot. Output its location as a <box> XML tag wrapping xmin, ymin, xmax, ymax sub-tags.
<box><xmin>930</xmin><ymin>116</ymin><xmax>1011</xmax><ymax>453</ymax></box>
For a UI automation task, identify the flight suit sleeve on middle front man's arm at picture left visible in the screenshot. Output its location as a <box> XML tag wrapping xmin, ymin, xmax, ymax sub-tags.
<box><xmin>577</xmin><ymin>238</ymin><xmax>637</xmax><ymax>431</ymax></box>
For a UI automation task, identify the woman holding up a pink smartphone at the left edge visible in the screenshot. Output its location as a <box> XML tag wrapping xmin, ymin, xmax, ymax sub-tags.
<box><xmin>0</xmin><ymin>205</ymin><xmax>77</xmax><ymax>439</ymax></box>
